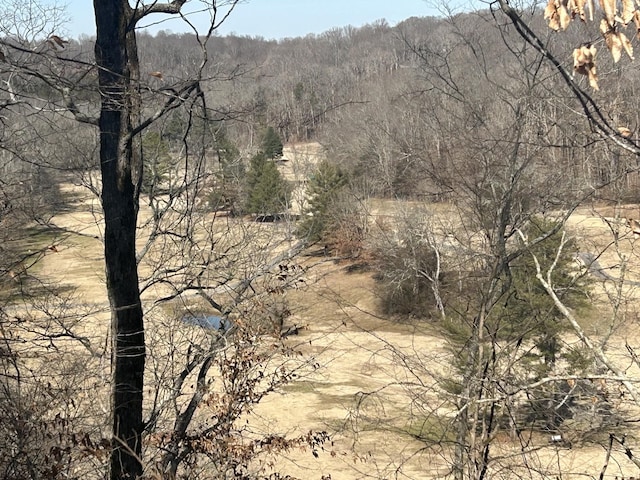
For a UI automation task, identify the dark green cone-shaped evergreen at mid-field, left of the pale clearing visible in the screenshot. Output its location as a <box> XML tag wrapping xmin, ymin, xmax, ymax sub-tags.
<box><xmin>244</xmin><ymin>152</ymin><xmax>290</xmax><ymax>215</ymax></box>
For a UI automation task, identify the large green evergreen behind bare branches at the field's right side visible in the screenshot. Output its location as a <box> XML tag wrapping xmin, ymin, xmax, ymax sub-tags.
<box><xmin>491</xmin><ymin>217</ymin><xmax>589</xmax><ymax>430</ymax></box>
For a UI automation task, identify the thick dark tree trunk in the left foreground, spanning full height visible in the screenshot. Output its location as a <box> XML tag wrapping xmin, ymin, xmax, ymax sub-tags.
<box><xmin>94</xmin><ymin>0</ymin><xmax>145</xmax><ymax>480</ymax></box>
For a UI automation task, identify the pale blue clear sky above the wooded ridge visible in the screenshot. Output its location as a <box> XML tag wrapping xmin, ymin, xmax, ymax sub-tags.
<box><xmin>61</xmin><ymin>0</ymin><xmax>438</xmax><ymax>39</ymax></box>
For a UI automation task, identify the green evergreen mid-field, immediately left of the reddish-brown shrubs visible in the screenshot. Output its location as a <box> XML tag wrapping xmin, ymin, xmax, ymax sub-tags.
<box><xmin>297</xmin><ymin>160</ymin><xmax>347</xmax><ymax>242</ymax></box>
